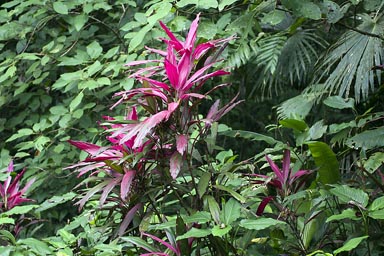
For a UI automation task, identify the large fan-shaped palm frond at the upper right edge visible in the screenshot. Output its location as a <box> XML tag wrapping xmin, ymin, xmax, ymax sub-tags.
<box><xmin>317</xmin><ymin>15</ymin><xmax>384</xmax><ymax>101</ymax></box>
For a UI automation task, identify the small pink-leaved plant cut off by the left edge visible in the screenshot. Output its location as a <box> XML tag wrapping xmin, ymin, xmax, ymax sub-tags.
<box><xmin>0</xmin><ymin>161</ymin><xmax>35</xmax><ymax>211</ymax></box>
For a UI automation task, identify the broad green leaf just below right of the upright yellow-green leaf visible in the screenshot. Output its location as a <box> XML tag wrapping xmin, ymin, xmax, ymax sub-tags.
<box><xmin>330</xmin><ymin>185</ymin><xmax>369</xmax><ymax>207</ymax></box>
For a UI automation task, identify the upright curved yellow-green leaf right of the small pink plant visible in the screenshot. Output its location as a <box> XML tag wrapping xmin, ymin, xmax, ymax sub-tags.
<box><xmin>306</xmin><ymin>141</ymin><xmax>340</xmax><ymax>184</ymax></box>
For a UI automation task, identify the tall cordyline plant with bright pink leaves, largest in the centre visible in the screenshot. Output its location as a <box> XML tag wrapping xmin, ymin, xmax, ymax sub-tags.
<box><xmin>69</xmin><ymin>15</ymin><xmax>239</xmax><ymax>234</ymax></box>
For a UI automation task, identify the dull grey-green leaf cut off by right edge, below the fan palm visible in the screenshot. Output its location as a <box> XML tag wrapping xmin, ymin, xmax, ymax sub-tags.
<box><xmin>345</xmin><ymin>127</ymin><xmax>384</xmax><ymax>150</ymax></box>
